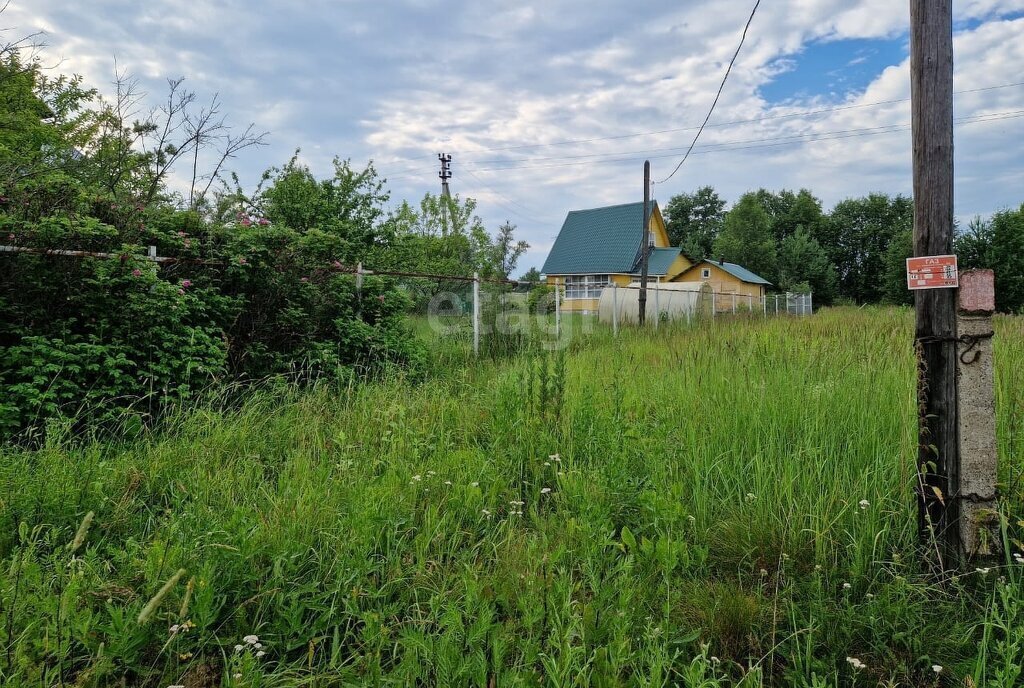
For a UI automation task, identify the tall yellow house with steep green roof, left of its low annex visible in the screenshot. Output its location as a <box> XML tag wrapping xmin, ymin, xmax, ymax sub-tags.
<box><xmin>541</xmin><ymin>202</ymin><xmax>692</xmax><ymax>312</ymax></box>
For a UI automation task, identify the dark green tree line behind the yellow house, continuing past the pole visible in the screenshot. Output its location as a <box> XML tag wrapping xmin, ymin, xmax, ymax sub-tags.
<box><xmin>665</xmin><ymin>186</ymin><xmax>1024</xmax><ymax>312</ymax></box>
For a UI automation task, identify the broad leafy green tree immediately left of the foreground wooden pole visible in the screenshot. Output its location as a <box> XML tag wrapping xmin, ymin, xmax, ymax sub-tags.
<box><xmin>815</xmin><ymin>194</ymin><xmax>913</xmax><ymax>303</ymax></box>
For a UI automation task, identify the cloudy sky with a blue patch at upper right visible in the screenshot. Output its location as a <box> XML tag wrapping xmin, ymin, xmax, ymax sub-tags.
<box><xmin>6</xmin><ymin>0</ymin><xmax>1024</xmax><ymax>272</ymax></box>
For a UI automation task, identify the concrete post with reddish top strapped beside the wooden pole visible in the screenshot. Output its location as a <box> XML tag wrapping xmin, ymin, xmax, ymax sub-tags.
<box><xmin>956</xmin><ymin>270</ymin><xmax>1002</xmax><ymax>558</ymax></box>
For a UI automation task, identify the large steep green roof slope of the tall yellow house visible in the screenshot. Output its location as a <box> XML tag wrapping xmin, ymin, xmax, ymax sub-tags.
<box><xmin>541</xmin><ymin>201</ymin><xmax>657</xmax><ymax>274</ymax></box>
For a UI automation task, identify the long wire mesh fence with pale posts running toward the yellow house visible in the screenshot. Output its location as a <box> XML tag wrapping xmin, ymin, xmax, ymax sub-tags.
<box><xmin>0</xmin><ymin>246</ymin><xmax>814</xmax><ymax>356</ymax></box>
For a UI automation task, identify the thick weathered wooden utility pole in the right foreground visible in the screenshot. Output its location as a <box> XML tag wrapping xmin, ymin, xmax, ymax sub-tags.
<box><xmin>910</xmin><ymin>0</ymin><xmax>962</xmax><ymax>567</ymax></box>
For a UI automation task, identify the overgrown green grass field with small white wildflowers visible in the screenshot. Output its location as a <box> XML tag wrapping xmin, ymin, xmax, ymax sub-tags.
<box><xmin>0</xmin><ymin>309</ymin><xmax>1024</xmax><ymax>688</ymax></box>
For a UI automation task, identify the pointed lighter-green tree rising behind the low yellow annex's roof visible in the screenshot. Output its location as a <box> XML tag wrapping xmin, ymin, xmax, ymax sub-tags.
<box><xmin>713</xmin><ymin>194</ymin><xmax>777</xmax><ymax>283</ymax></box>
